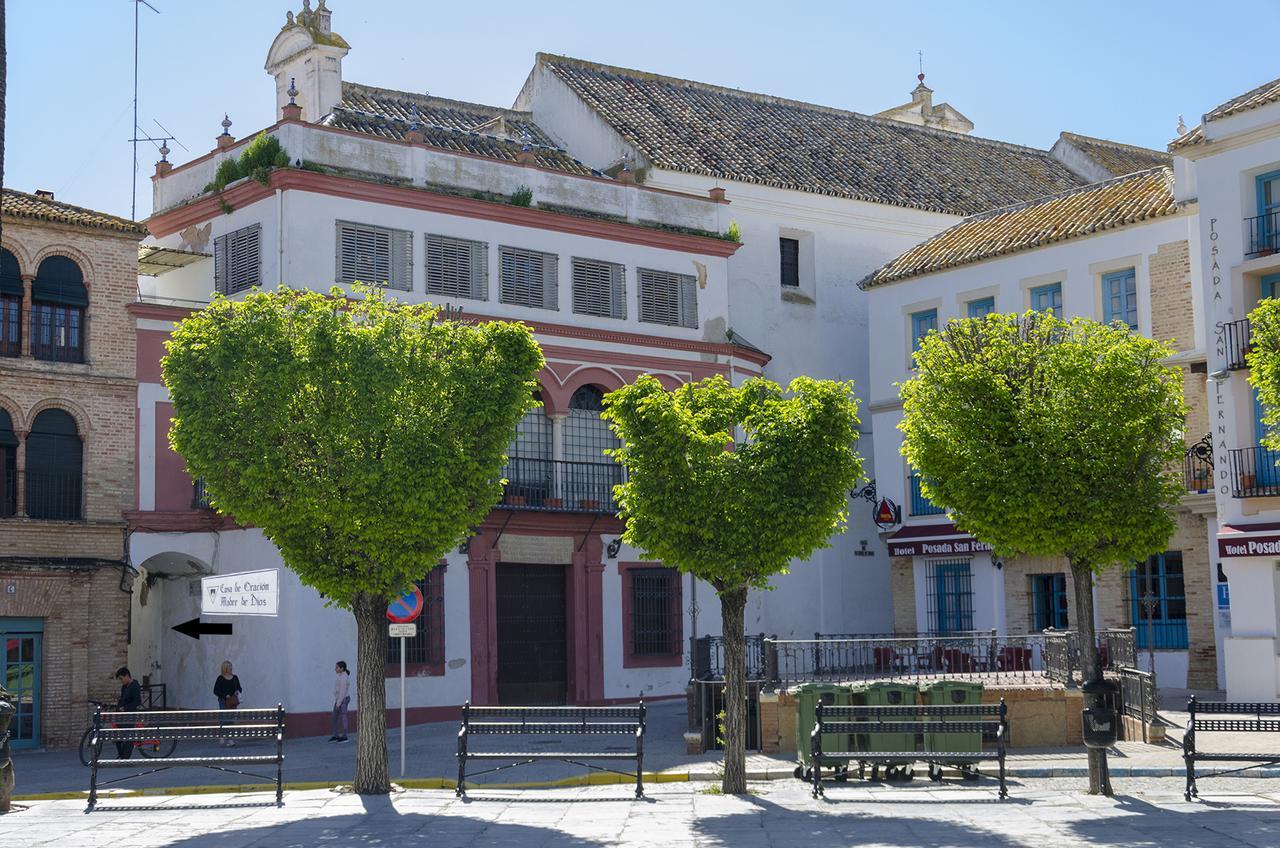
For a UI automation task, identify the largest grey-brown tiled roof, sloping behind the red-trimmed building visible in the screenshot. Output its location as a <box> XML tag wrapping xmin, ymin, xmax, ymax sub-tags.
<box><xmin>538</xmin><ymin>54</ymin><xmax>1084</xmax><ymax>214</ymax></box>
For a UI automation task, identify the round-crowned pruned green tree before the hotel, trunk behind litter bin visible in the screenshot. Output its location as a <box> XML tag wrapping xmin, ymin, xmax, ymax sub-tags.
<box><xmin>899</xmin><ymin>313</ymin><xmax>1187</xmax><ymax>794</ymax></box>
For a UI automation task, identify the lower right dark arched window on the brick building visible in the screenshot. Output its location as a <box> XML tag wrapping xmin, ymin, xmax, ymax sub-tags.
<box><xmin>27</xmin><ymin>409</ymin><xmax>84</xmax><ymax>521</ymax></box>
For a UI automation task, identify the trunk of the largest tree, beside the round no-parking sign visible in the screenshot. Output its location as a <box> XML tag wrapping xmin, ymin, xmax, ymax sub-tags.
<box><xmin>351</xmin><ymin>593</ymin><xmax>392</xmax><ymax>795</ymax></box>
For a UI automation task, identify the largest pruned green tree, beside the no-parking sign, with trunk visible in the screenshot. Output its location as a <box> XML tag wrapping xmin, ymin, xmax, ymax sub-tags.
<box><xmin>163</xmin><ymin>288</ymin><xmax>543</xmax><ymax>794</ymax></box>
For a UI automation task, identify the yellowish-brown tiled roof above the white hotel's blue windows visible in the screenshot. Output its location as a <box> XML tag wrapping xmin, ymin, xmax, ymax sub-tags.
<box><xmin>858</xmin><ymin>167</ymin><xmax>1178</xmax><ymax>288</ymax></box>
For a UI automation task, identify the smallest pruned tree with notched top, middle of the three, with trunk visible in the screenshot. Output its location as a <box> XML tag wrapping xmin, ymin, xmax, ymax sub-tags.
<box><xmin>604</xmin><ymin>377</ymin><xmax>863</xmax><ymax>793</ymax></box>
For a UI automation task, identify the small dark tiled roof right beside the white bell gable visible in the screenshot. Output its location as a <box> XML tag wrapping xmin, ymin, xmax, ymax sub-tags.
<box><xmin>323</xmin><ymin>82</ymin><xmax>599</xmax><ymax>175</ymax></box>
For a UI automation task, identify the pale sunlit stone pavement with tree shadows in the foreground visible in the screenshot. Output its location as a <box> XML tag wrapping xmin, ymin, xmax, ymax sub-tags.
<box><xmin>0</xmin><ymin>778</ymin><xmax>1280</xmax><ymax>848</ymax></box>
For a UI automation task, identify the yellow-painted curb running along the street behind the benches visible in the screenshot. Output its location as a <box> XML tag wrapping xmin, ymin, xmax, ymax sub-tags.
<box><xmin>13</xmin><ymin>766</ymin><xmax>1280</xmax><ymax>802</ymax></box>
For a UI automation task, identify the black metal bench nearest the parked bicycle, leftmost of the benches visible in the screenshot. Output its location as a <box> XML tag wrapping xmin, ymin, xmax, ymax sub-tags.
<box><xmin>86</xmin><ymin>705</ymin><xmax>284</xmax><ymax>812</ymax></box>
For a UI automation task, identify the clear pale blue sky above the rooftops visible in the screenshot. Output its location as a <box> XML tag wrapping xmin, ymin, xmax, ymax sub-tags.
<box><xmin>5</xmin><ymin>0</ymin><xmax>1280</xmax><ymax>218</ymax></box>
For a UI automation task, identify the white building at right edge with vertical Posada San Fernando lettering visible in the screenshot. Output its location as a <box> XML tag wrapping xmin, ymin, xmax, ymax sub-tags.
<box><xmin>1170</xmin><ymin>81</ymin><xmax>1280</xmax><ymax>701</ymax></box>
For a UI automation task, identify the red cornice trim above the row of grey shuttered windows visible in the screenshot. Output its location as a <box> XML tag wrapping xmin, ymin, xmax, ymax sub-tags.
<box><xmin>147</xmin><ymin>168</ymin><xmax>741</xmax><ymax>257</ymax></box>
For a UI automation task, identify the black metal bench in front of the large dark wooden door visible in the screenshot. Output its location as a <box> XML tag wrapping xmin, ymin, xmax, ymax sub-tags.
<box><xmin>456</xmin><ymin>701</ymin><xmax>644</xmax><ymax>798</ymax></box>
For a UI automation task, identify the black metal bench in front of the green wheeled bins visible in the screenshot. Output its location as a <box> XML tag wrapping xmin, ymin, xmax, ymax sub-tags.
<box><xmin>809</xmin><ymin>698</ymin><xmax>1009</xmax><ymax>798</ymax></box>
